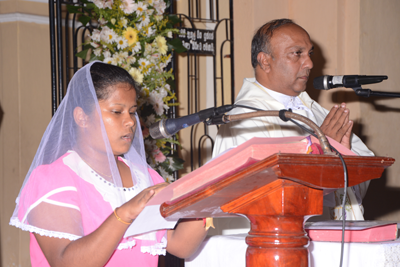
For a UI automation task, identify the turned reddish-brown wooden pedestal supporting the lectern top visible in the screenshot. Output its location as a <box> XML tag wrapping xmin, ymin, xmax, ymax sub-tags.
<box><xmin>225</xmin><ymin>179</ymin><xmax>323</xmax><ymax>267</ymax></box>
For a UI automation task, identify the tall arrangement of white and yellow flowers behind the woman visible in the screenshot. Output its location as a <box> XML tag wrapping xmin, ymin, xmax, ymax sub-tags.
<box><xmin>67</xmin><ymin>0</ymin><xmax>185</xmax><ymax>181</ymax></box>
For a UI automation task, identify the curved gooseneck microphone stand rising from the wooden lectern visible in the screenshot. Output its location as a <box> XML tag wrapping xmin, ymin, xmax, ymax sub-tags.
<box><xmin>217</xmin><ymin>110</ymin><xmax>336</xmax><ymax>155</ymax></box>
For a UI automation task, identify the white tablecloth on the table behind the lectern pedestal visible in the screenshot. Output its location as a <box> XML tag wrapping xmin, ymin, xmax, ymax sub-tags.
<box><xmin>185</xmin><ymin>234</ymin><xmax>400</xmax><ymax>267</ymax></box>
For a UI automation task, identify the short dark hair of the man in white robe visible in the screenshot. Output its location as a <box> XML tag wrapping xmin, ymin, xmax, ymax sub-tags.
<box><xmin>251</xmin><ymin>19</ymin><xmax>297</xmax><ymax>68</ymax></box>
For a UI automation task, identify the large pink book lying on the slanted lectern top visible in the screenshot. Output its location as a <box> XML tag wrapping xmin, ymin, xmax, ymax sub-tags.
<box><xmin>147</xmin><ymin>136</ymin><xmax>355</xmax><ymax>206</ymax></box>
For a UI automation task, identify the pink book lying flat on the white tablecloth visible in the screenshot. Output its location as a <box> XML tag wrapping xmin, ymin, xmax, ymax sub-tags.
<box><xmin>304</xmin><ymin>221</ymin><xmax>398</xmax><ymax>243</ymax></box>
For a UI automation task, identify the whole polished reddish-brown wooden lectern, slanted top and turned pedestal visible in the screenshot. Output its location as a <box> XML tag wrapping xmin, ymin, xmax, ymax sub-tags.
<box><xmin>161</xmin><ymin>153</ymin><xmax>394</xmax><ymax>267</ymax></box>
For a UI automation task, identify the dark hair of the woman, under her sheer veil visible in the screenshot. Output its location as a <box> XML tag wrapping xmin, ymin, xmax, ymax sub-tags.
<box><xmin>90</xmin><ymin>62</ymin><xmax>140</xmax><ymax>101</ymax></box>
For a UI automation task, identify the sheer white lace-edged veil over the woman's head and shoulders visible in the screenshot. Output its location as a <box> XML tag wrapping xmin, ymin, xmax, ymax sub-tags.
<box><xmin>10</xmin><ymin>61</ymin><xmax>154</xmax><ymax>245</ymax></box>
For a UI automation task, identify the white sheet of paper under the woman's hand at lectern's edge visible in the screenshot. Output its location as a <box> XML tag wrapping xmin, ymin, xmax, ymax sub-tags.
<box><xmin>124</xmin><ymin>205</ymin><xmax>178</xmax><ymax>237</ymax></box>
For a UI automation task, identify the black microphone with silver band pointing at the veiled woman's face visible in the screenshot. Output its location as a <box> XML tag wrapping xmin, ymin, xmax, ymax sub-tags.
<box><xmin>149</xmin><ymin>105</ymin><xmax>235</xmax><ymax>139</ymax></box>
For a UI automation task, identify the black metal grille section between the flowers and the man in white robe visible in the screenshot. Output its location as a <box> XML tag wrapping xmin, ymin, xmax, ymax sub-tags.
<box><xmin>177</xmin><ymin>0</ymin><xmax>235</xmax><ymax>171</ymax></box>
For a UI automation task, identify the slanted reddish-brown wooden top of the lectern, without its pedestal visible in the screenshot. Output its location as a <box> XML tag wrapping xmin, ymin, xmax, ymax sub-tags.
<box><xmin>161</xmin><ymin>153</ymin><xmax>394</xmax><ymax>218</ymax></box>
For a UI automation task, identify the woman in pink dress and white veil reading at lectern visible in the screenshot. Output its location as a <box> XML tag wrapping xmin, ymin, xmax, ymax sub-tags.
<box><xmin>10</xmin><ymin>62</ymin><xmax>207</xmax><ymax>267</ymax></box>
